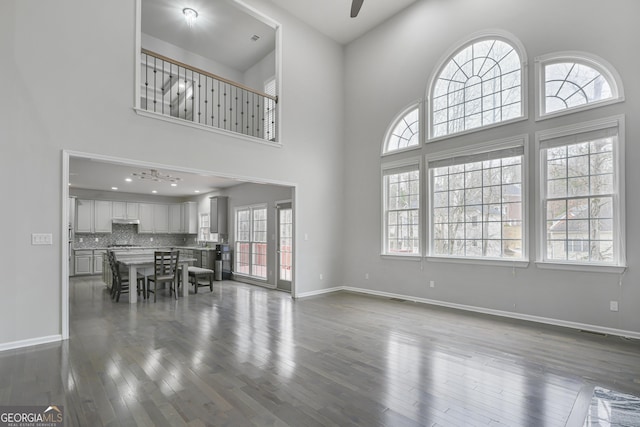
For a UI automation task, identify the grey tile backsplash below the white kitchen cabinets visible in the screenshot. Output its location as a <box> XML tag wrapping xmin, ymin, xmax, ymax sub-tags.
<box><xmin>73</xmin><ymin>224</ymin><xmax>197</xmax><ymax>249</ymax></box>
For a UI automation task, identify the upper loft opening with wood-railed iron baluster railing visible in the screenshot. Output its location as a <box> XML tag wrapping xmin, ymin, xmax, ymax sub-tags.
<box><xmin>136</xmin><ymin>0</ymin><xmax>279</xmax><ymax>143</ymax></box>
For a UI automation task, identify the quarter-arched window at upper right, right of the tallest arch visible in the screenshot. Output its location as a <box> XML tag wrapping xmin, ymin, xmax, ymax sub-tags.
<box><xmin>536</xmin><ymin>52</ymin><xmax>623</xmax><ymax>118</ymax></box>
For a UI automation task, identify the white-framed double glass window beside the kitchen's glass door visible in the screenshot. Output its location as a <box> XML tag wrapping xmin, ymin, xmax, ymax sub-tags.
<box><xmin>235</xmin><ymin>206</ymin><xmax>267</xmax><ymax>279</ymax></box>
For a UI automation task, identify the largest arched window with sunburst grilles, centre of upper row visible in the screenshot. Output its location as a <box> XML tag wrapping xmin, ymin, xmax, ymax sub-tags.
<box><xmin>429</xmin><ymin>34</ymin><xmax>526</xmax><ymax>139</ymax></box>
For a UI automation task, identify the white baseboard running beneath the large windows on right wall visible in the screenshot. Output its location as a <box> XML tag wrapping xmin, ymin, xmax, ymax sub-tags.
<box><xmin>330</xmin><ymin>286</ymin><xmax>640</xmax><ymax>339</ymax></box>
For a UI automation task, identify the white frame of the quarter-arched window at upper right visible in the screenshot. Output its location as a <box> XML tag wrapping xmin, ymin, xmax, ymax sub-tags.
<box><xmin>534</xmin><ymin>51</ymin><xmax>624</xmax><ymax>121</ymax></box>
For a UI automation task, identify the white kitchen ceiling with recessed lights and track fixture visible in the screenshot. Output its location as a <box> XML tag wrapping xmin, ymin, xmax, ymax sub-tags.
<box><xmin>69</xmin><ymin>157</ymin><xmax>241</xmax><ymax>197</ymax></box>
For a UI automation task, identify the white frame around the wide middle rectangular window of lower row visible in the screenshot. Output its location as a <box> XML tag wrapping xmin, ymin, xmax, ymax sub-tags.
<box><xmin>425</xmin><ymin>134</ymin><xmax>530</xmax><ymax>268</ymax></box>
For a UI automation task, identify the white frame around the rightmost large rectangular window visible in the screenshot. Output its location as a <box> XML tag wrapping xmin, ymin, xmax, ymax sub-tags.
<box><xmin>535</xmin><ymin>115</ymin><xmax>626</xmax><ymax>274</ymax></box>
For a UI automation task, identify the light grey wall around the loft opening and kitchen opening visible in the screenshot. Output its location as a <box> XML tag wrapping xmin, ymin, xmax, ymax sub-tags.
<box><xmin>0</xmin><ymin>0</ymin><xmax>344</xmax><ymax>348</ymax></box>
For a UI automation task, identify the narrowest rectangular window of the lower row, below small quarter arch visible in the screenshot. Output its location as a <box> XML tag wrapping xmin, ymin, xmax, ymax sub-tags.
<box><xmin>383</xmin><ymin>164</ymin><xmax>420</xmax><ymax>255</ymax></box>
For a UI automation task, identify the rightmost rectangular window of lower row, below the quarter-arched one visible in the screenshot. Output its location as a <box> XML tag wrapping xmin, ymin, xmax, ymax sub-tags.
<box><xmin>537</xmin><ymin>118</ymin><xmax>625</xmax><ymax>266</ymax></box>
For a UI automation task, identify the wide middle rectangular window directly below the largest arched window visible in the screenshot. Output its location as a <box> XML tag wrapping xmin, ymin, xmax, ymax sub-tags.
<box><xmin>428</xmin><ymin>137</ymin><xmax>527</xmax><ymax>260</ymax></box>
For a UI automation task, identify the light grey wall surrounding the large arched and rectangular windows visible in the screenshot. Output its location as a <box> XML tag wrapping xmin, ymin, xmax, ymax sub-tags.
<box><xmin>343</xmin><ymin>0</ymin><xmax>640</xmax><ymax>334</ymax></box>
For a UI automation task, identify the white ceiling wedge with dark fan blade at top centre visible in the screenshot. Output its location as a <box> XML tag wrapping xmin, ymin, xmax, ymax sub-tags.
<box><xmin>271</xmin><ymin>0</ymin><xmax>416</xmax><ymax>44</ymax></box>
